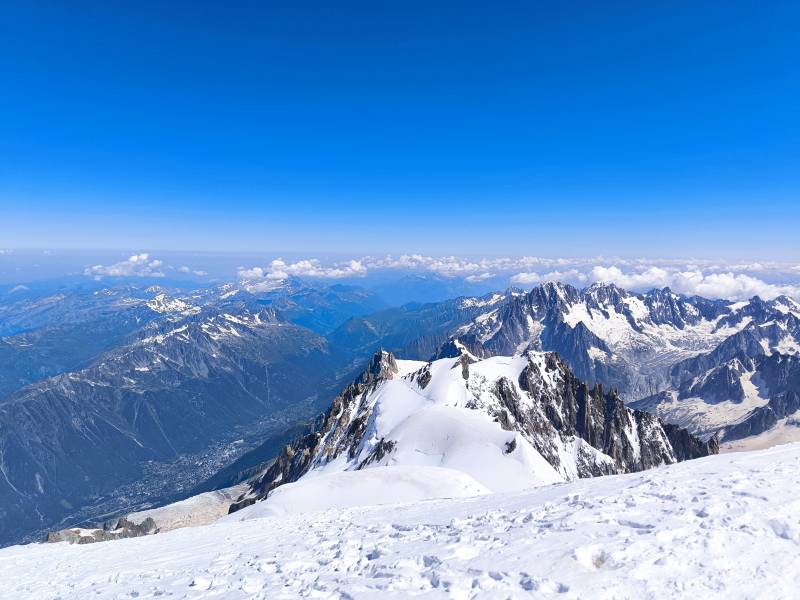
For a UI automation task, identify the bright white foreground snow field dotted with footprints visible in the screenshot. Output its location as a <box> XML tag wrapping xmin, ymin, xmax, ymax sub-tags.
<box><xmin>0</xmin><ymin>444</ymin><xmax>800</xmax><ymax>600</ymax></box>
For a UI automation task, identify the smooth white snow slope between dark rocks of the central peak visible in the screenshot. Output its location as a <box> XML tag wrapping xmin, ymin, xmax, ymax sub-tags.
<box><xmin>304</xmin><ymin>355</ymin><xmax>563</xmax><ymax>491</ymax></box>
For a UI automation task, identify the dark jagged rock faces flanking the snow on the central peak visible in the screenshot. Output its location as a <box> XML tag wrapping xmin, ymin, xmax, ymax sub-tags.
<box><xmin>230</xmin><ymin>348</ymin><xmax>718</xmax><ymax>512</ymax></box>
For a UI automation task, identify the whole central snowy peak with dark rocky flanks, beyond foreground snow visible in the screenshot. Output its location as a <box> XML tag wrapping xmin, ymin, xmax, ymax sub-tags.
<box><xmin>234</xmin><ymin>342</ymin><xmax>717</xmax><ymax>508</ymax></box>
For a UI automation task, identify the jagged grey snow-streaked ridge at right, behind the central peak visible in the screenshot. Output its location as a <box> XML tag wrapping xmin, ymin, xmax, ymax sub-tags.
<box><xmin>455</xmin><ymin>283</ymin><xmax>800</xmax><ymax>400</ymax></box>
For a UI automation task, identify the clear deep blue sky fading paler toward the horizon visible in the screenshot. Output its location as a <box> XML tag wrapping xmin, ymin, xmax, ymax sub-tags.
<box><xmin>0</xmin><ymin>0</ymin><xmax>800</xmax><ymax>258</ymax></box>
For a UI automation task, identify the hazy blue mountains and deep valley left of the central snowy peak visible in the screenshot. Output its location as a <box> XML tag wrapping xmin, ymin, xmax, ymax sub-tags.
<box><xmin>0</xmin><ymin>279</ymin><xmax>400</xmax><ymax>545</ymax></box>
